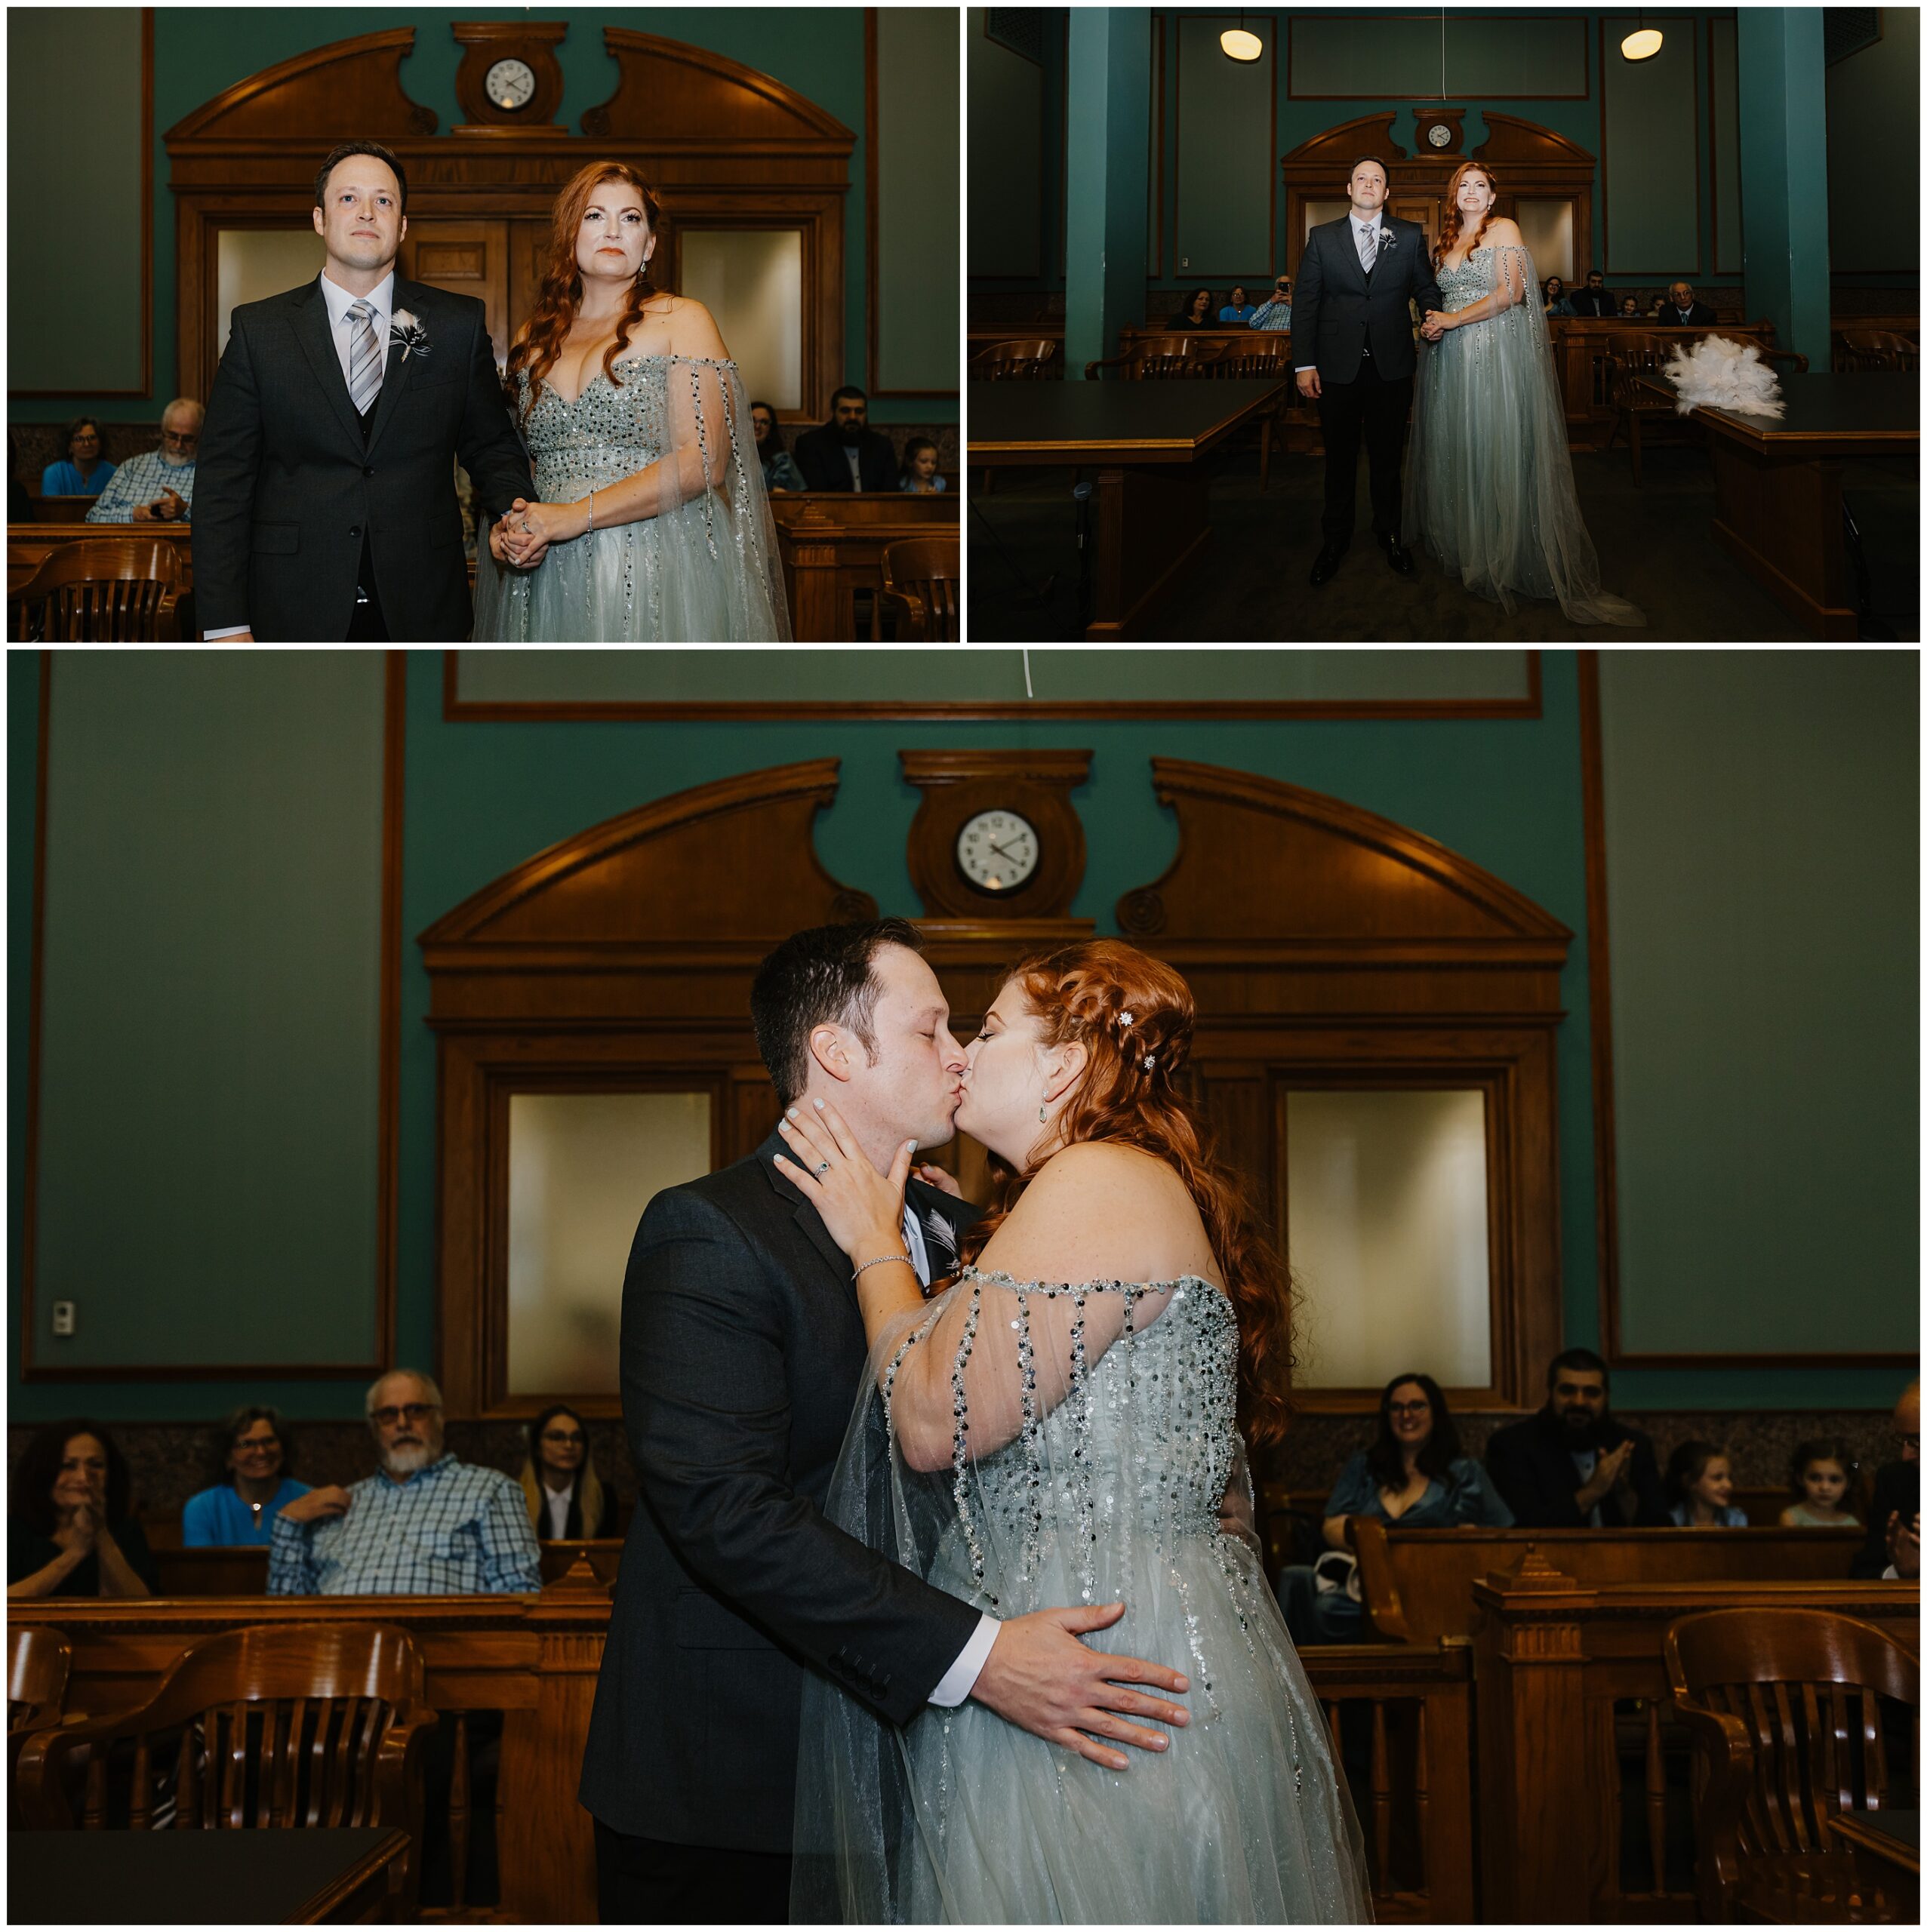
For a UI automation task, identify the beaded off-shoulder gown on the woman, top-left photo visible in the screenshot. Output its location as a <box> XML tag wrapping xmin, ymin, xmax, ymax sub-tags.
<box><xmin>476</xmin><ymin>355</ymin><xmax>789</xmax><ymax>643</ymax></box>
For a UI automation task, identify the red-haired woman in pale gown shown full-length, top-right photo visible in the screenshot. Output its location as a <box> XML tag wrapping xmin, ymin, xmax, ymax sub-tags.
<box><xmin>1401</xmin><ymin>162</ymin><xmax>1645</xmax><ymax>626</ymax></box>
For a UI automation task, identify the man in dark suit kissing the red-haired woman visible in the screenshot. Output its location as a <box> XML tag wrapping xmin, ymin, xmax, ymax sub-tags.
<box><xmin>580</xmin><ymin>920</ymin><xmax>1187</xmax><ymax>1924</ymax></box>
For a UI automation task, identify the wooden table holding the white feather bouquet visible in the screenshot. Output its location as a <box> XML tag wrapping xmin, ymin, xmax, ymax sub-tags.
<box><xmin>1639</xmin><ymin>375</ymin><xmax>1921</xmax><ymax>643</ymax></box>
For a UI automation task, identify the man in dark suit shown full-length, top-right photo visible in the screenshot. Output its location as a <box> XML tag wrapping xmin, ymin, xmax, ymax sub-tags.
<box><xmin>1291</xmin><ymin>155</ymin><xmax>1445</xmax><ymax>583</ymax></box>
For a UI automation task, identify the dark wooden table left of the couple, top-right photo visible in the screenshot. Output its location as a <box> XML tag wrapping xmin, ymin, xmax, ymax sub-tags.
<box><xmin>968</xmin><ymin>377</ymin><xmax>1285</xmax><ymax>643</ymax></box>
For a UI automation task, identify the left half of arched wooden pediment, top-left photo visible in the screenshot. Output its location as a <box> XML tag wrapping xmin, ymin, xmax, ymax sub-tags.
<box><xmin>165</xmin><ymin>27</ymin><xmax>441</xmax><ymax>143</ymax></box>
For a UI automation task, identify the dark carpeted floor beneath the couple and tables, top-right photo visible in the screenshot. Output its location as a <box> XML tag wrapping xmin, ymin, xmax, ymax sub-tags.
<box><xmin>965</xmin><ymin>435</ymin><xmax>1919</xmax><ymax>645</ymax></box>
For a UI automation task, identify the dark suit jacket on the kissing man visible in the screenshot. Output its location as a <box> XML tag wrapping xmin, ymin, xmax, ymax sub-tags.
<box><xmin>580</xmin><ymin>1134</ymin><xmax>978</xmax><ymax>1853</ymax></box>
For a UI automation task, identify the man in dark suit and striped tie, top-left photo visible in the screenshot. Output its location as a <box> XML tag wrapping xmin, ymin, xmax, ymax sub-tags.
<box><xmin>193</xmin><ymin>141</ymin><xmax>530</xmax><ymax>643</ymax></box>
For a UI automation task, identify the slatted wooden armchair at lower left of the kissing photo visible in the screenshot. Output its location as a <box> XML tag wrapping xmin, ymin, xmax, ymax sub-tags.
<box><xmin>17</xmin><ymin>1623</ymin><xmax>435</xmax><ymax>1912</ymax></box>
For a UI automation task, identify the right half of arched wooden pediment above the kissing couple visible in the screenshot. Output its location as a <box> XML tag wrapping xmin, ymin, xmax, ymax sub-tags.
<box><xmin>1117</xmin><ymin>758</ymin><xmax>1571</xmax><ymax>1011</ymax></box>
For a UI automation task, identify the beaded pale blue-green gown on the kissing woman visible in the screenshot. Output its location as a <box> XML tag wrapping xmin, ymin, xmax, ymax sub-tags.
<box><xmin>793</xmin><ymin>1267</ymin><xmax>1371</xmax><ymax>1924</ymax></box>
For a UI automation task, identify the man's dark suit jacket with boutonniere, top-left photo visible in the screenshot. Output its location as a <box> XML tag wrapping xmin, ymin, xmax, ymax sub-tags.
<box><xmin>193</xmin><ymin>276</ymin><xmax>531</xmax><ymax>643</ymax></box>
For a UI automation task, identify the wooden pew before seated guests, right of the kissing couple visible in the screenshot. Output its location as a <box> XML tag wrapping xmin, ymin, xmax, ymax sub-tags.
<box><xmin>1345</xmin><ymin>1517</ymin><xmax>1865</xmax><ymax>1644</ymax></box>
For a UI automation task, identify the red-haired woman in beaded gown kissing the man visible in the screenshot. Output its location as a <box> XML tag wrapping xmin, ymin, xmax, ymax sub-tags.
<box><xmin>769</xmin><ymin>941</ymin><xmax>1371</xmax><ymax>1924</ymax></box>
